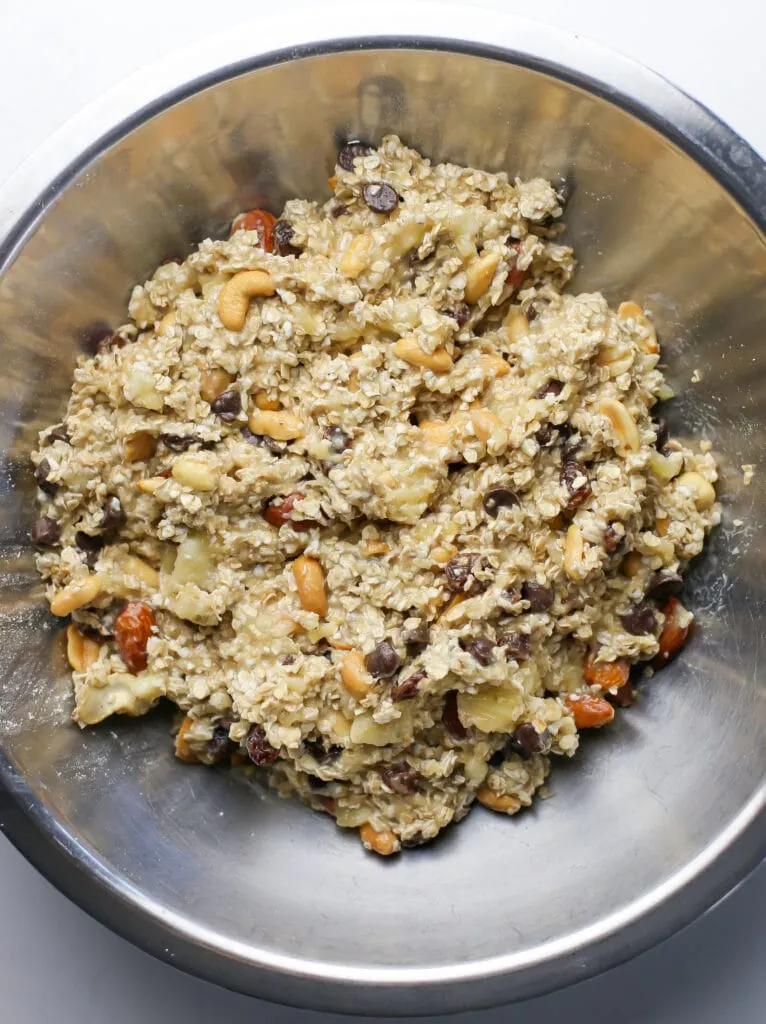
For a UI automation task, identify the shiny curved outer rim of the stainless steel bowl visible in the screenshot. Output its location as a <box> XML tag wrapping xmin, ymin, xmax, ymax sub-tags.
<box><xmin>0</xmin><ymin>6</ymin><xmax>766</xmax><ymax>1014</ymax></box>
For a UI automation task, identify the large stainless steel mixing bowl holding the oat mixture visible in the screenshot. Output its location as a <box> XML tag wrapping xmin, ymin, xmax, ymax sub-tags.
<box><xmin>0</xmin><ymin>2</ymin><xmax>766</xmax><ymax>1014</ymax></box>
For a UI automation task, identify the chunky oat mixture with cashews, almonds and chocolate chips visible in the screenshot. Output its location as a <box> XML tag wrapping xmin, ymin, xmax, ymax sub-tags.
<box><xmin>33</xmin><ymin>136</ymin><xmax>720</xmax><ymax>854</ymax></box>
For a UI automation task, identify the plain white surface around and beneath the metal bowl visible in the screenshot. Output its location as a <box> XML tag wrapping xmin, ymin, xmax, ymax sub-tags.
<box><xmin>0</xmin><ymin>0</ymin><xmax>766</xmax><ymax>1024</ymax></box>
